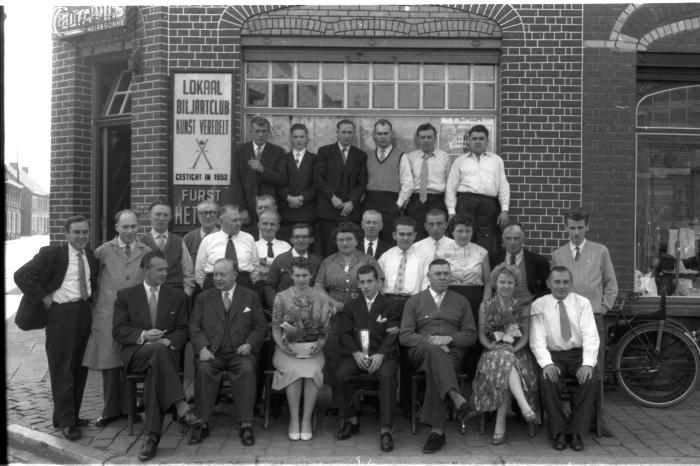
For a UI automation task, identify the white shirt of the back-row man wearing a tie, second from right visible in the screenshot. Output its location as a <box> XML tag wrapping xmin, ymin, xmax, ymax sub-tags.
<box><xmin>396</xmin><ymin>149</ymin><xmax>451</xmax><ymax>207</ymax></box>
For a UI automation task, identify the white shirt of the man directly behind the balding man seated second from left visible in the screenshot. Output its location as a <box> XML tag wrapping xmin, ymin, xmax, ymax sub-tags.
<box><xmin>194</xmin><ymin>230</ymin><xmax>260</xmax><ymax>286</ymax></box>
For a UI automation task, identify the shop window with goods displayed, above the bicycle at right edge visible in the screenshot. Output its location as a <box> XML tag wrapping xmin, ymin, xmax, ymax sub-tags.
<box><xmin>636</xmin><ymin>86</ymin><xmax>700</xmax><ymax>296</ymax></box>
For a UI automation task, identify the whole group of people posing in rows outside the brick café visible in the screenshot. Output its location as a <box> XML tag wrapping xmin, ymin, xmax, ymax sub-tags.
<box><xmin>15</xmin><ymin>114</ymin><xmax>617</xmax><ymax>461</ymax></box>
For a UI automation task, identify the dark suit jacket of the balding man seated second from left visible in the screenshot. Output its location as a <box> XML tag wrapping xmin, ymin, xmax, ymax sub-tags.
<box><xmin>190</xmin><ymin>285</ymin><xmax>267</xmax><ymax>354</ymax></box>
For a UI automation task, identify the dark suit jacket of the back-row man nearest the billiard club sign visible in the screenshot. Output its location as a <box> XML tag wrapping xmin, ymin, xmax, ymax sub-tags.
<box><xmin>227</xmin><ymin>142</ymin><xmax>286</xmax><ymax>223</ymax></box>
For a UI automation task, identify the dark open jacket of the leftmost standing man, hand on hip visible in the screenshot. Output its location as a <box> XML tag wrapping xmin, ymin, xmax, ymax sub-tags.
<box><xmin>14</xmin><ymin>243</ymin><xmax>100</xmax><ymax>330</ymax></box>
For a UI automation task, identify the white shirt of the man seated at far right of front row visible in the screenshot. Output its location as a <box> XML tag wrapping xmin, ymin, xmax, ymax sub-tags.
<box><xmin>530</xmin><ymin>293</ymin><xmax>600</xmax><ymax>367</ymax></box>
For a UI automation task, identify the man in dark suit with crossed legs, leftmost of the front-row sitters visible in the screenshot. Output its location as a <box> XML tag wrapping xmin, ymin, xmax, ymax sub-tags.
<box><xmin>112</xmin><ymin>250</ymin><xmax>199</xmax><ymax>461</ymax></box>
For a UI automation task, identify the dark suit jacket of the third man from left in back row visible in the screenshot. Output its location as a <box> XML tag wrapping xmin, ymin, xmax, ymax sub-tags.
<box><xmin>314</xmin><ymin>143</ymin><xmax>367</xmax><ymax>222</ymax></box>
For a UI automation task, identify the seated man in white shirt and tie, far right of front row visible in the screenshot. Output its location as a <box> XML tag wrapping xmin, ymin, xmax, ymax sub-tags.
<box><xmin>530</xmin><ymin>266</ymin><xmax>600</xmax><ymax>451</ymax></box>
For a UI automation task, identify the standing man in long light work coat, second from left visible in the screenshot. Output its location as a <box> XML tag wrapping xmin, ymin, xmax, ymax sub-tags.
<box><xmin>83</xmin><ymin>209</ymin><xmax>151</xmax><ymax>428</ymax></box>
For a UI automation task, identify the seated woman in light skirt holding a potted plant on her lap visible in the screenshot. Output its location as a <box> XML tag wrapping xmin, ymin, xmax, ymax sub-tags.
<box><xmin>272</xmin><ymin>257</ymin><xmax>330</xmax><ymax>440</ymax></box>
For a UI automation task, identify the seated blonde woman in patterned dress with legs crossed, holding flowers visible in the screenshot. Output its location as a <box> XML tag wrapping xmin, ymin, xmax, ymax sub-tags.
<box><xmin>472</xmin><ymin>263</ymin><xmax>537</xmax><ymax>445</ymax></box>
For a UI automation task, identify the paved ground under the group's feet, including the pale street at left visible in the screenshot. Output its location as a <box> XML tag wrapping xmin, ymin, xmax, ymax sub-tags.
<box><xmin>5</xmin><ymin>304</ymin><xmax>700</xmax><ymax>464</ymax></box>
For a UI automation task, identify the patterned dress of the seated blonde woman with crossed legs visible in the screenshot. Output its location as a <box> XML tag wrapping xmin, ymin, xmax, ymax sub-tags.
<box><xmin>472</xmin><ymin>297</ymin><xmax>538</xmax><ymax>412</ymax></box>
